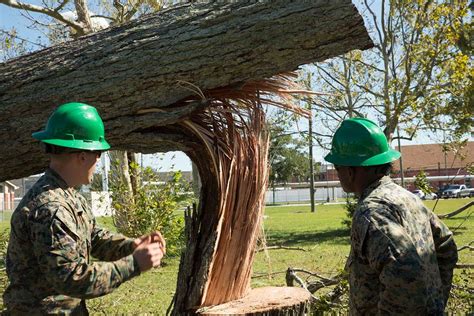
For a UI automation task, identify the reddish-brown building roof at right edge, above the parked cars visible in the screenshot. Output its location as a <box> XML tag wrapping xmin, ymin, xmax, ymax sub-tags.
<box><xmin>393</xmin><ymin>142</ymin><xmax>474</xmax><ymax>170</ymax></box>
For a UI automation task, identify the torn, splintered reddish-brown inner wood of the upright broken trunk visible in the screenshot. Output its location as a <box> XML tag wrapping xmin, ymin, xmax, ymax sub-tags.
<box><xmin>183</xmin><ymin>74</ymin><xmax>308</xmax><ymax>306</ymax></box>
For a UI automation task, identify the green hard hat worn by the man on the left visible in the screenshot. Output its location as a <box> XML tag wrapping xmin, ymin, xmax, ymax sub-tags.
<box><xmin>32</xmin><ymin>102</ymin><xmax>110</xmax><ymax>150</ymax></box>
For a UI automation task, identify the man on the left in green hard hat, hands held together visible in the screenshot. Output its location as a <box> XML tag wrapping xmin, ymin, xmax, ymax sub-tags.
<box><xmin>4</xmin><ymin>103</ymin><xmax>165</xmax><ymax>315</ymax></box>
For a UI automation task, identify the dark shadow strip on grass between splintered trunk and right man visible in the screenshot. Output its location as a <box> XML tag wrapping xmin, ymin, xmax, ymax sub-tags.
<box><xmin>267</xmin><ymin>228</ymin><xmax>350</xmax><ymax>246</ymax></box>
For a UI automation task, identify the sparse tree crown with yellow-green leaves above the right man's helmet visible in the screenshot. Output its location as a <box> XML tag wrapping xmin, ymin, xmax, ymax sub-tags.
<box><xmin>309</xmin><ymin>0</ymin><xmax>474</xmax><ymax>144</ymax></box>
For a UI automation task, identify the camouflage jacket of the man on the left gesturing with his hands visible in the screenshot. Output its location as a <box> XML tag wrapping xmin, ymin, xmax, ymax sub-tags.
<box><xmin>4</xmin><ymin>169</ymin><xmax>140</xmax><ymax>314</ymax></box>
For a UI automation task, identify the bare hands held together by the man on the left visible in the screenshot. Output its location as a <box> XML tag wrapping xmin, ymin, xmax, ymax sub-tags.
<box><xmin>133</xmin><ymin>232</ymin><xmax>166</xmax><ymax>272</ymax></box>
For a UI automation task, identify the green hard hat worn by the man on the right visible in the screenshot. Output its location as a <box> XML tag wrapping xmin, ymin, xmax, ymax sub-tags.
<box><xmin>324</xmin><ymin>117</ymin><xmax>400</xmax><ymax>166</ymax></box>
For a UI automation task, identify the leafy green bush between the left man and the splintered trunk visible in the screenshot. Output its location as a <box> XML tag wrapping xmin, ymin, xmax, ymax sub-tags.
<box><xmin>111</xmin><ymin>163</ymin><xmax>193</xmax><ymax>256</ymax></box>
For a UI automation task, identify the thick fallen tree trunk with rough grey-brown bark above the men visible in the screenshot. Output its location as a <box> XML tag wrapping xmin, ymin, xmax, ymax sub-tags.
<box><xmin>0</xmin><ymin>0</ymin><xmax>372</xmax><ymax>181</ymax></box>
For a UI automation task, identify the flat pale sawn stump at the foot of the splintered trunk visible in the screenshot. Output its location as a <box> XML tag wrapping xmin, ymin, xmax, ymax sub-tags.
<box><xmin>197</xmin><ymin>287</ymin><xmax>311</xmax><ymax>316</ymax></box>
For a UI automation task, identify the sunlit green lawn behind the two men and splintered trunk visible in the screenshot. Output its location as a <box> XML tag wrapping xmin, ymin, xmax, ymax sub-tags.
<box><xmin>0</xmin><ymin>199</ymin><xmax>474</xmax><ymax>315</ymax></box>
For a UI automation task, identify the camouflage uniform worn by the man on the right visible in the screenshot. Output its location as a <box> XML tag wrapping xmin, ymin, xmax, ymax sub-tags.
<box><xmin>347</xmin><ymin>176</ymin><xmax>458</xmax><ymax>315</ymax></box>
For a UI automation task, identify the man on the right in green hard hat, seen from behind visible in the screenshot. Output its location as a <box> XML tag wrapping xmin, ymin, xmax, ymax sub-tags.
<box><xmin>325</xmin><ymin>118</ymin><xmax>458</xmax><ymax>315</ymax></box>
